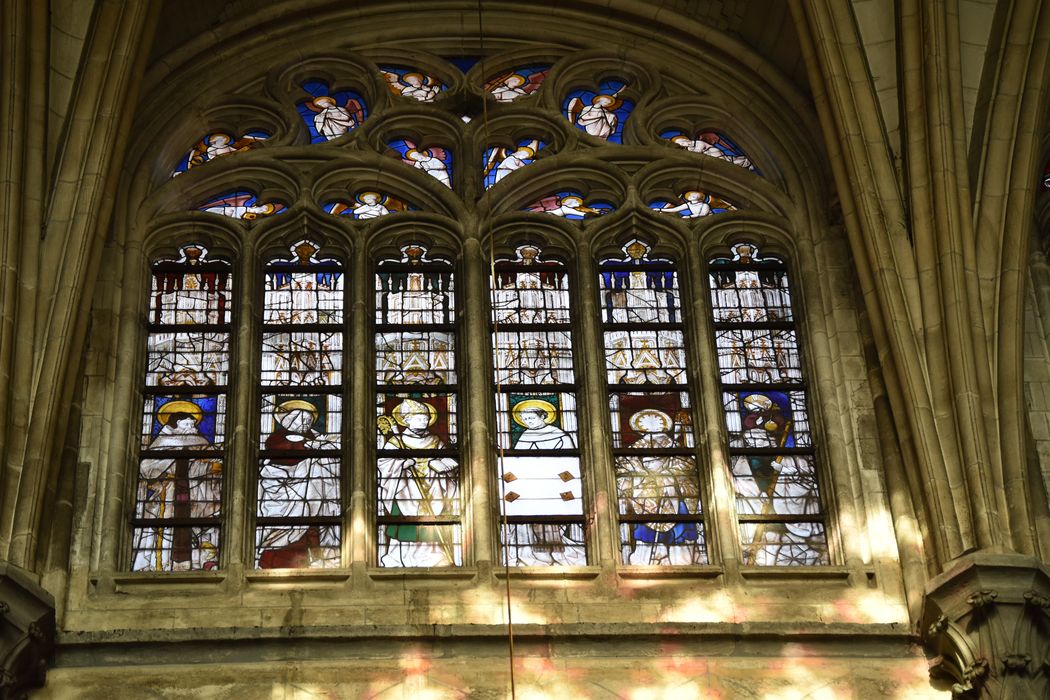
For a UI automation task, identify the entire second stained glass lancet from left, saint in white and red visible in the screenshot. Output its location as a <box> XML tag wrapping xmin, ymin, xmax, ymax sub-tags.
<box><xmin>255</xmin><ymin>240</ymin><xmax>345</xmax><ymax>569</ymax></box>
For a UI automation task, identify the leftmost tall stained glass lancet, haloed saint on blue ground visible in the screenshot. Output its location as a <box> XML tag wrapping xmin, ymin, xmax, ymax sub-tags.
<box><xmin>131</xmin><ymin>245</ymin><xmax>233</xmax><ymax>571</ymax></box>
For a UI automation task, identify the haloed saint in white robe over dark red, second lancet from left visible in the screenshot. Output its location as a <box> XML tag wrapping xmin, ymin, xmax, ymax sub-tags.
<box><xmin>258</xmin><ymin>399</ymin><xmax>339</xmax><ymax>569</ymax></box>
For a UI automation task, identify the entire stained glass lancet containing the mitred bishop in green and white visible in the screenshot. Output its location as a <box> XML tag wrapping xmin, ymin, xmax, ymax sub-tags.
<box><xmin>375</xmin><ymin>245</ymin><xmax>463</xmax><ymax>567</ymax></box>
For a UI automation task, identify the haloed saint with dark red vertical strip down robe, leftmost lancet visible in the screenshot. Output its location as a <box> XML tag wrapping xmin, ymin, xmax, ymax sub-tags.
<box><xmin>135</xmin><ymin>399</ymin><xmax>223</xmax><ymax>571</ymax></box>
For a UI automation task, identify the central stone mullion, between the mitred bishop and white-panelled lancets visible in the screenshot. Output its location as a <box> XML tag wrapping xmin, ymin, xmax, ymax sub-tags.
<box><xmin>456</xmin><ymin>235</ymin><xmax>493</xmax><ymax>569</ymax></box>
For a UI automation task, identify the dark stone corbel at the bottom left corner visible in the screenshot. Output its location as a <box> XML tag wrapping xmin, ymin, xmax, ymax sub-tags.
<box><xmin>0</xmin><ymin>561</ymin><xmax>55</xmax><ymax>700</ymax></box>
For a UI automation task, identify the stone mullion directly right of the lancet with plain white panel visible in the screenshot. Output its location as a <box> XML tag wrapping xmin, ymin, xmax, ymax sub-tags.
<box><xmin>573</xmin><ymin>235</ymin><xmax>621</xmax><ymax>568</ymax></box>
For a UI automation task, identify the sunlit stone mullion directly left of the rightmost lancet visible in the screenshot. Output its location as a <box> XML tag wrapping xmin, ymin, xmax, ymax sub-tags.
<box><xmin>683</xmin><ymin>247</ymin><xmax>742</xmax><ymax>579</ymax></box>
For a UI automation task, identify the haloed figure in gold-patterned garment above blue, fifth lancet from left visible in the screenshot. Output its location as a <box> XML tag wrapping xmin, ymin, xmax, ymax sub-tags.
<box><xmin>616</xmin><ymin>408</ymin><xmax>702</xmax><ymax>565</ymax></box>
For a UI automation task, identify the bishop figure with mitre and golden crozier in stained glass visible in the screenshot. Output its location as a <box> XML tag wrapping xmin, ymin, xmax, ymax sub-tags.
<box><xmin>378</xmin><ymin>399</ymin><xmax>459</xmax><ymax>567</ymax></box>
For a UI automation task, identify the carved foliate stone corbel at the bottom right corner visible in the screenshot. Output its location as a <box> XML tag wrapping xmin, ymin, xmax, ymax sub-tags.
<box><xmin>922</xmin><ymin>552</ymin><xmax>1050</xmax><ymax>700</ymax></box>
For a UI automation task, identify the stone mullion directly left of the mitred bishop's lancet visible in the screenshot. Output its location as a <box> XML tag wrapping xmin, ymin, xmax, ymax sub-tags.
<box><xmin>341</xmin><ymin>243</ymin><xmax>369</xmax><ymax>568</ymax></box>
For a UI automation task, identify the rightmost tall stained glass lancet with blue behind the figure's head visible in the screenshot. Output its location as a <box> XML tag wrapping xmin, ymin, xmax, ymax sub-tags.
<box><xmin>710</xmin><ymin>243</ymin><xmax>828</xmax><ymax>566</ymax></box>
